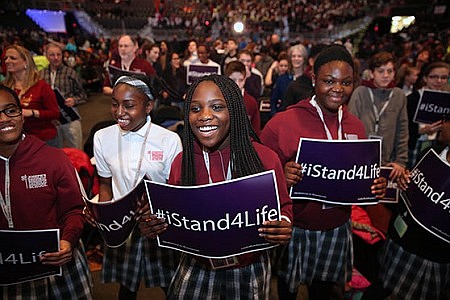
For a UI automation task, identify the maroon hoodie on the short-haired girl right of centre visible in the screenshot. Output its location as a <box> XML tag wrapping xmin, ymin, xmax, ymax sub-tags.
<box><xmin>260</xmin><ymin>99</ymin><xmax>366</xmax><ymax>230</ymax></box>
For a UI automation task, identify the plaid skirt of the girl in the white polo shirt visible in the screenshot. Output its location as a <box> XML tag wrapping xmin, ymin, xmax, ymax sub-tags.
<box><xmin>102</xmin><ymin>228</ymin><xmax>179</xmax><ymax>292</ymax></box>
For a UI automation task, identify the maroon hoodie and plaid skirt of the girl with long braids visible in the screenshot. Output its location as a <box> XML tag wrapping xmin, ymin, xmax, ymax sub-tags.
<box><xmin>167</xmin><ymin>142</ymin><xmax>292</xmax><ymax>299</ymax></box>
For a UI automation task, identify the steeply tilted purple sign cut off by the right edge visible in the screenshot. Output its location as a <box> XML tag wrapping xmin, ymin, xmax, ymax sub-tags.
<box><xmin>400</xmin><ymin>150</ymin><xmax>450</xmax><ymax>243</ymax></box>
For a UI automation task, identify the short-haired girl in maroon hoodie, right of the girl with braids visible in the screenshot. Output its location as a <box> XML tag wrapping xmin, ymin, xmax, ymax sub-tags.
<box><xmin>261</xmin><ymin>45</ymin><xmax>386</xmax><ymax>299</ymax></box>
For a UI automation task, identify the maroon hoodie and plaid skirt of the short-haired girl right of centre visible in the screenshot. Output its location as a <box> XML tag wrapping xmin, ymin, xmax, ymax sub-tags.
<box><xmin>260</xmin><ymin>99</ymin><xmax>366</xmax><ymax>293</ymax></box>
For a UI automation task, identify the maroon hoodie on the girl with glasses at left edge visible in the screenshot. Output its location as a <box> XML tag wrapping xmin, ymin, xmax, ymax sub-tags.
<box><xmin>0</xmin><ymin>135</ymin><xmax>84</xmax><ymax>245</ymax></box>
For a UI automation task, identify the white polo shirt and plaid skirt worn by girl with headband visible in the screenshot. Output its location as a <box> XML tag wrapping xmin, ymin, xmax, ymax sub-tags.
<box><xmin>94</xmin><ymin>117</ymin><xmax>181</xmax><ymax>291</ymax></box>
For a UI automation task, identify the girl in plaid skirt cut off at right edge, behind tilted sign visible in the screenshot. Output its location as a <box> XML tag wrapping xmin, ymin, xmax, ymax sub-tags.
<box><xmin>362</xmin><ymin>115</ymin><xmax>450</xmax><ymax>300</ymax></box>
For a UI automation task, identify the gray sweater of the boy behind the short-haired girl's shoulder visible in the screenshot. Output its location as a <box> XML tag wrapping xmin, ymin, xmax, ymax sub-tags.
<box><xmin>348</xmin><ymin>86</ymin><xmax>409</xmax><ymax>167</ymax></box>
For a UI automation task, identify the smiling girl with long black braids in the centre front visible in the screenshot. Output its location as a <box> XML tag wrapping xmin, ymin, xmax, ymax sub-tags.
<box><xmin>141</xmin><ymin>75</ymin><xmax>292</xmax><ymax>299</ymax></box>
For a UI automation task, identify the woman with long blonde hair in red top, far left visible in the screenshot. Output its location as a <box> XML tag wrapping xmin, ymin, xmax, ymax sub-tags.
<box><xmin>3</xmin><ymin>45</ymin><xmax>59</xmax><ymax>147</ymax></box>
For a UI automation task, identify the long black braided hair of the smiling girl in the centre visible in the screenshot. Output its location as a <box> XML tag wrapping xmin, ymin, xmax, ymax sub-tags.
<box><xmin>181</xmin><ymin>74</ymin><xmax>264</xmax><ymax>185</ymax></box>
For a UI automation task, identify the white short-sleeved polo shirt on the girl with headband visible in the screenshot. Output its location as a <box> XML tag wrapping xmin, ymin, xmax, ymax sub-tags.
<box><xmin>94</xmin><ymin>117</ymin><xmax>182</xmax><ymax>199</ymax></box>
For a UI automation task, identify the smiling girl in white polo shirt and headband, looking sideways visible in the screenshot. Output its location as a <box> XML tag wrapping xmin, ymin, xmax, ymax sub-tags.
<box><xmin>94</xmin><ymin>75</ymin><xmax>181</xmax><ymax>299</ymax></box>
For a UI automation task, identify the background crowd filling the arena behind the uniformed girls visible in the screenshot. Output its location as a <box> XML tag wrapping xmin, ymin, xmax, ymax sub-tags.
<box><xmin>0</xmin><ymin>0</ymin><xmax>450</xmax><ymax>298</ymax></box>
